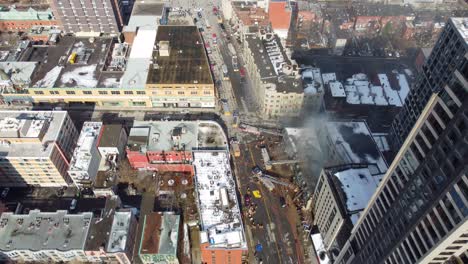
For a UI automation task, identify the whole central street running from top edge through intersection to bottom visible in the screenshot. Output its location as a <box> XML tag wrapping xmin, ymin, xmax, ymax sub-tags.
<box><xmin>165</xmin><ymin>0</ymin><xmax>305</xmax><ymax>264</ymax></box>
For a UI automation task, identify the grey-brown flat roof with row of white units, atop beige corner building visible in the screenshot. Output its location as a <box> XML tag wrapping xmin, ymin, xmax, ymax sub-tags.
<box><xmin>245</xmin><ymin>33</ymin><xmax>303</xmax><ymax>93</ymax></box>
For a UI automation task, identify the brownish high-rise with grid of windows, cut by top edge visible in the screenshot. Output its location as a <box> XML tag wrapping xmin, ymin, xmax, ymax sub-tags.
<box><xmin>49</xmin><ymin>0</ymin><xmax>124</xmax><ymax>34</ymax></box>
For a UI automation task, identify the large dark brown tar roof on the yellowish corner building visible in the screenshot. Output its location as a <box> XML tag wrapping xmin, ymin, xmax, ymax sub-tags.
<box><xmin>148</xmin><ymin>26</ymin><xmax>213</xmax><ymax>84</ymax></box>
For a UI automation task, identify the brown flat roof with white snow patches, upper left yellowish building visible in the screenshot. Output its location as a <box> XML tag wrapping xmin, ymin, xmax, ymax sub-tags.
<box><xmin>22</xmin><ymin>36</ymin><xmax>123</xmax><ymax>88</ymax></box>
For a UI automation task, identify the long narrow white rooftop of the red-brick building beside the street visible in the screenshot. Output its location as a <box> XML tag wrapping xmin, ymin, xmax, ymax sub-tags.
<box><xmin>193</xmin><ymin>151</ymin><xmax>247</xmax><ymax>249</ymax></box>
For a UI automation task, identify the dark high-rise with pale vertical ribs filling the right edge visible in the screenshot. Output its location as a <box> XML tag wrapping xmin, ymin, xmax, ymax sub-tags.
<box><xmin>335</xmin><ymin>18</ymin><xmax>468</xmax><ymax>264</ymax></box>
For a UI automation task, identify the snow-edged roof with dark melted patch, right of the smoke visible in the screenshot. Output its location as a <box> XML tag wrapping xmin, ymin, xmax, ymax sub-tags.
<box><xmin>326</xmin><ymin>121</ymin><xmax>388</xmax><ymax>175</ymax></box>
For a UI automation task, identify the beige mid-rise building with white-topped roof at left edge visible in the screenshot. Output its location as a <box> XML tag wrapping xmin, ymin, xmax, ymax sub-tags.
<box><xmin>0</xmin><ymin>111</ymin><xmax>78</xmax><ymax>187</ymax></box>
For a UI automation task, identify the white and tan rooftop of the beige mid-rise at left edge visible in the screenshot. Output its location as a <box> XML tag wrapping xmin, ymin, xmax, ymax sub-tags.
<box><xmin>0</xmin><ymin>111</ymin><xmax>67</xmax><ymax>157</ymax></box>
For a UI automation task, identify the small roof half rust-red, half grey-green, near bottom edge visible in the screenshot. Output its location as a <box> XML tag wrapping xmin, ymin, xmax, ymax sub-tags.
<box><xmin>139</xmin><ymin>212</ymin><xmax>180</xmax><ymax>255</ymax></box>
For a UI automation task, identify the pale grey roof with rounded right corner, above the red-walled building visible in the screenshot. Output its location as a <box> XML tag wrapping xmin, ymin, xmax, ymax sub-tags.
<box><xmin>127</xmin><ymin>121</ymin><xmax>227</xmax><ymax>152</ymax></box>
